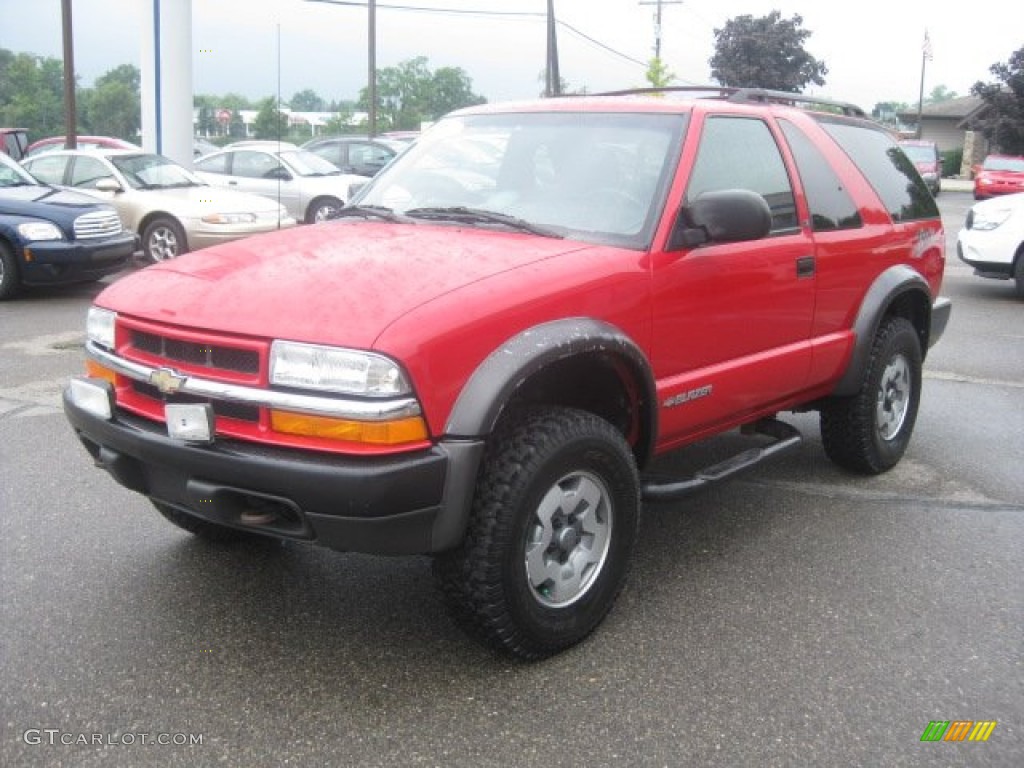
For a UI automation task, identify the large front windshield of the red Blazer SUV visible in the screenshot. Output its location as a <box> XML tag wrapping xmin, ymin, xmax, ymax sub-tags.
<box><xmin>354</xmin><ymin>112</ymin><xmax>686</xmax><ymax>248</ymax></box>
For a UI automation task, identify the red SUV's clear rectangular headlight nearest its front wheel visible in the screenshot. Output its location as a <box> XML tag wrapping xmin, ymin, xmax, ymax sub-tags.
<box><xmin>270</xmin><ymin>341</ymin><xmax>411</xmax><ymax>397</ymax></box>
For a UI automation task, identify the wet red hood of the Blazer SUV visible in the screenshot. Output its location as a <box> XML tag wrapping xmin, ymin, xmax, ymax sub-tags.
<box><xmin>96</xmin><ymin>221</ymin><xmax>593</xmax><ymax>349</ymax></box>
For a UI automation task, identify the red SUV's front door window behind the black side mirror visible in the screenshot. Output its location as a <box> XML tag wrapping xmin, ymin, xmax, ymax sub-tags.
<box><xmin>686</xmin><ymin>116</ymin><xmax>799</xmax><ymax>232</ymax></box>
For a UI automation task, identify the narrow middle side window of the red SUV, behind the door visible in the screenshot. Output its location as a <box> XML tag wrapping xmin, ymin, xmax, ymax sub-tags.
<box><xmin>778</xmin><ymin>120</ymin><xmax>863</xmax><ymax>232</ymax></box>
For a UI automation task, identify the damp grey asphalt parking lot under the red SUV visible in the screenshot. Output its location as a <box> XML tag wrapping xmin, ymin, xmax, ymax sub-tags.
<box><xmin>0</xmin><ymin>190</ymin><xmax>1024</xmax><ymax>767</ymax></box>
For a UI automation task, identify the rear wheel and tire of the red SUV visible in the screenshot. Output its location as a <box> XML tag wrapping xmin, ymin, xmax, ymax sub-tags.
<box><xmin>821</xmin><ymin>317</ymin><xmax>923</xmax><ymax>475</ymax></box>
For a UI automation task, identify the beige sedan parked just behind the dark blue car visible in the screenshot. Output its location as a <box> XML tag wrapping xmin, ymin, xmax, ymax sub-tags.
<box><xmin>23</xmin><ymin>150</ymin><xmax>296</xmax><ymax>261</ymax></box>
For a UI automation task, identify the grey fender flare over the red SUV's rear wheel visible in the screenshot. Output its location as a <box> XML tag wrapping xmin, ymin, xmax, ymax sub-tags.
<box><xmin>833</xmin><ymin>264</ymin><xmax>932</xmax><ymax>396</ymax></box>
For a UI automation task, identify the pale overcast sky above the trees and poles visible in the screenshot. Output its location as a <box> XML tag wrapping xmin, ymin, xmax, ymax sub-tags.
<box><xmin>0</xmin><ymin>0</ymin><xmax>1024</xmax><ymax>110</ymax></box>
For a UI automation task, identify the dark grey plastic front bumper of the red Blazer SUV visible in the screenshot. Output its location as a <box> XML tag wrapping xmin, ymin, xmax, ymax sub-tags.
<box><xmin>63</xmin><ymin>390</ymin><xmax>482</xmax><ymax>554</ymax></box>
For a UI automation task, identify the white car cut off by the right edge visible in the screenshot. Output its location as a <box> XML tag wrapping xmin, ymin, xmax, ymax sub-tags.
<box><xmin>956</xmin><ymin>193</ymin><xmax>1024</xmax><ymax>298</ymax></box>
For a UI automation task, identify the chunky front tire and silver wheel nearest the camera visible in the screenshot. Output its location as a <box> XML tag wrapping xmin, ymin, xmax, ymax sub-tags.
<box><xmin>434</xmin><ymin>408</ymin><xmax>640</xmax><ymax>659</ymax></box>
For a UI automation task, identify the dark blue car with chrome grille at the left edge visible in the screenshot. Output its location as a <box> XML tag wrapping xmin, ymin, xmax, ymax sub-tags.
<box><xmin>0</xmin><ymin>153</ymin><xmax>138</xmax><ymax>300</ymax></box>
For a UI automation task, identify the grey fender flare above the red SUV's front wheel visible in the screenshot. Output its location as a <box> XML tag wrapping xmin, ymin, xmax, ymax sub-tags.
<box><xmin>444</xmin><ymin>317</ymin><xmax>657</xmax><ymax>456</ymax></box>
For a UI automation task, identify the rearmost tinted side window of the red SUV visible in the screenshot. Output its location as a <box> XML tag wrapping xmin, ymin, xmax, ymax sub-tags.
<box><xmin>820</xmin><ymin>117</ymin><xmax>939</xmax><ymax>221</ymax></box>
